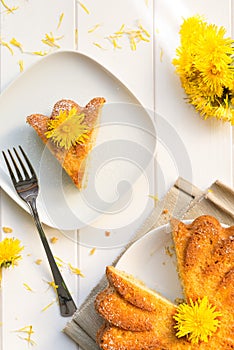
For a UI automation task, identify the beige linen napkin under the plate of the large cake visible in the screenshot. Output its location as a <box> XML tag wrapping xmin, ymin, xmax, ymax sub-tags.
<box><xmin>64</xmin><ymin>178</ymin><xmax>234</xmax><ymax>350</ymax></box>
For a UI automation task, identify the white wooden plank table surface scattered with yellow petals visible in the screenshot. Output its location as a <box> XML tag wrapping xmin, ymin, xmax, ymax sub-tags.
<box><xmin>0</xmin><ymin>0</ymin><xmax>231</xmax><ymax>350</ymax></box>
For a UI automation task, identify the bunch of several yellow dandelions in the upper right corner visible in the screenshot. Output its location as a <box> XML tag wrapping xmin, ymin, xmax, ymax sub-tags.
<box><xmin>172</xmin><ymin>16</ymin><xmax>234</xmax><ymax>125</ymax></box>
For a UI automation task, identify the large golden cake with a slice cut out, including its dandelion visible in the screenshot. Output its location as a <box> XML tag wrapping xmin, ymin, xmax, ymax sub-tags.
<box><xmin>95</xmin><ymin>215</ymin><xmax>234</xmax><ymax>350</ymax></box>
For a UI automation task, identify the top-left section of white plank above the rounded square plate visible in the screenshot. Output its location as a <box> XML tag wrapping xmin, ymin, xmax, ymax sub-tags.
<box><xmin>0</xmin><ymin>0</ymin><xmax>75</xmax><ymax>89</ymax></box>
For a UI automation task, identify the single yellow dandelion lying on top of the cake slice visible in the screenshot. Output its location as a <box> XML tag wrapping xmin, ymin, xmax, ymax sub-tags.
<box><xmin>45</xmin><ymin>108</ymin><xmax>89</xmax><ymax>150</ymax></box>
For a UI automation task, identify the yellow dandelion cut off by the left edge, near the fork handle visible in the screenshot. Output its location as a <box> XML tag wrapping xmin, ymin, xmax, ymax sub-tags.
<box><xmin>0</xmin><ymin>238</ymin><xmax>24</xmax><ymax>268</ymax></box>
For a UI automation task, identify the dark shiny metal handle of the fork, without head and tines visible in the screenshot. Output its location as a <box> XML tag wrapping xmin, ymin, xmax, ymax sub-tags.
<box><xmin>27</xmin><ymin>199</ymin><xmax>77</xmax><ymax>317</ymax></box>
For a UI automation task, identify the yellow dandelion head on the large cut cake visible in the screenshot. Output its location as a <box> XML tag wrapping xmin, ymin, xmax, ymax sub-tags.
<box><xmin>174</xmin><ymin>296</ymin><xmax>222</xmax><ymax>344</ymax></box>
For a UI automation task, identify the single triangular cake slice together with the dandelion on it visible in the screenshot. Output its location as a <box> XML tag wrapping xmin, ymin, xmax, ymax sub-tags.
<box><xmin>27</xmin><ymin>97</ymin><xmax>105</xmax><ymax>190</ymax></box>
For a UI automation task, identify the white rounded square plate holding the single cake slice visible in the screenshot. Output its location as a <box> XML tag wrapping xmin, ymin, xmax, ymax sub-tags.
<box><xmin>0</xmin><ymin>51</ymin><xmax>156</xmax><ymax>230</ymax></box>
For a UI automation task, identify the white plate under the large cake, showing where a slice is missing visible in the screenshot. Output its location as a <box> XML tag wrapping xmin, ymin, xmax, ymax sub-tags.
<box><xmin>116</xmin><ymin>220</ymin><xmax>191</xmax><ymax>302</ymax></box>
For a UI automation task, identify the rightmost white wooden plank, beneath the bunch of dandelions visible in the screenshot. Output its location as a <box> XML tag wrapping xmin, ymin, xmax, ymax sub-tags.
<box><xmin>155</xmin><ymin>0</ymin><xmax>232</xmax><ymax>195</ymax></box>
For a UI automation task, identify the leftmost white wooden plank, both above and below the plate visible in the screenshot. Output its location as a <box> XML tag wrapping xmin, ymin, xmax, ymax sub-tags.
<box><xmin>1</xmin><ymin>0</ymin><xmax>79</xmax><ymax>350</ymax></box>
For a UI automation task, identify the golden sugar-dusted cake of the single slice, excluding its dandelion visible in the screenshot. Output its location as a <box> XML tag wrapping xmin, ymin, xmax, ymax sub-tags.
<box><xmin>27</xmin><ymin>97</ymin><xmax>105</xmax><ymax>189</ymax></box>
